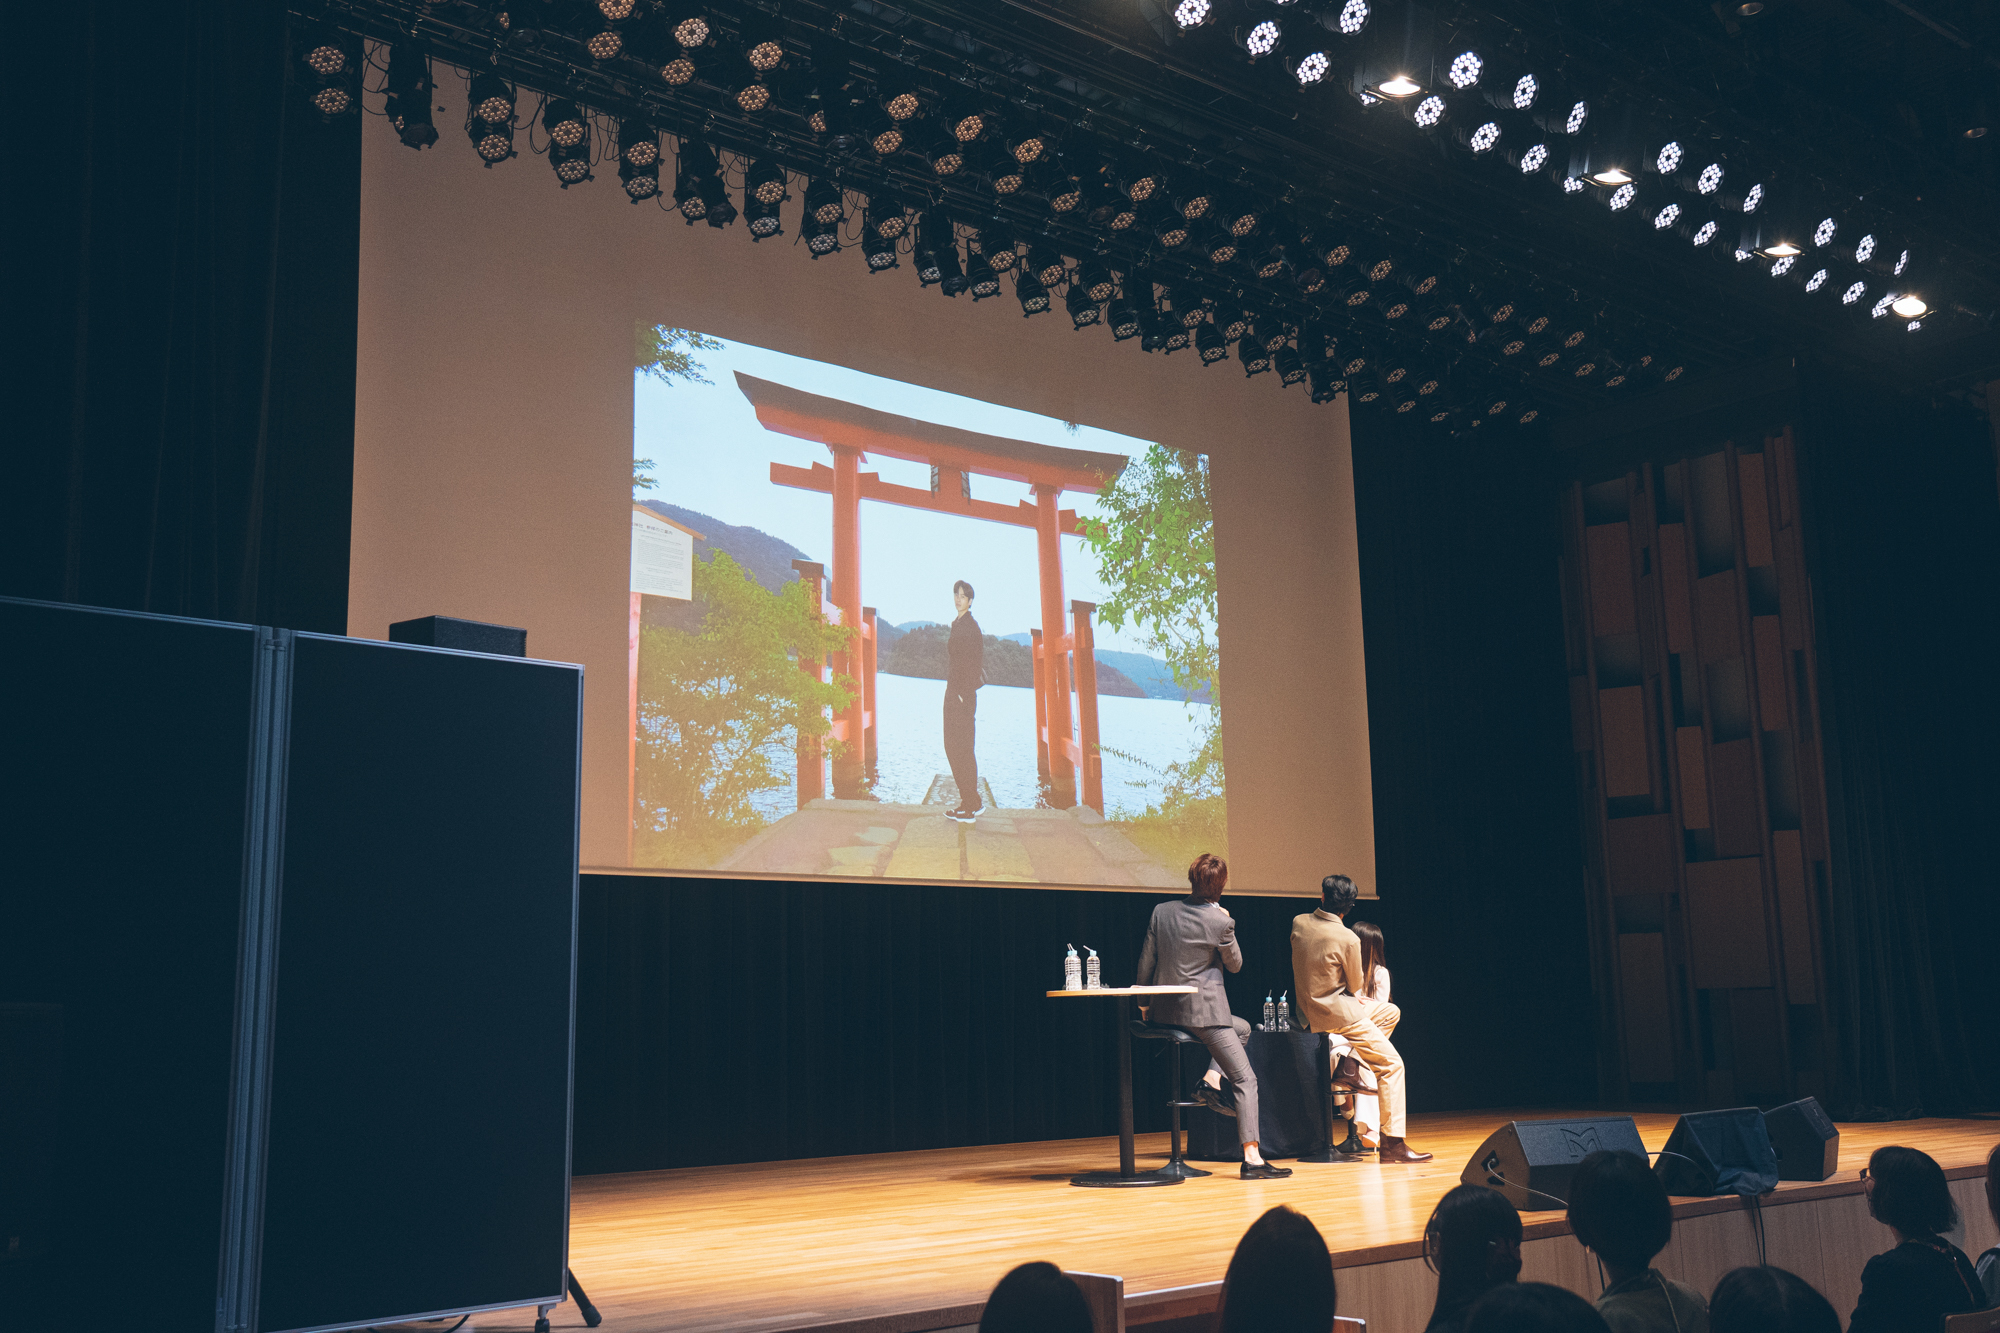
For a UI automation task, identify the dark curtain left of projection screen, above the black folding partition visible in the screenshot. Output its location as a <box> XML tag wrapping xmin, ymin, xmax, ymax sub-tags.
<box><xmin>0</xmin><ymin>0</ymin><xmax>360</xmax><ymax>632</ymax></box>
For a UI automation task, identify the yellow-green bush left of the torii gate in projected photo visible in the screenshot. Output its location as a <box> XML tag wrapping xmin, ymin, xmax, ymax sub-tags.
<box><xmin>634</xmin><ymin>550</ymin><xmax>856</xmax><ymax>869</ymax></box>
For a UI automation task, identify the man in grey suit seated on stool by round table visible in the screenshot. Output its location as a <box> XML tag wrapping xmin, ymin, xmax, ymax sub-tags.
<box><xmin>1138</xmin><ymin>853</ymin><xmax>1292</xmax><ymax>1181</ymax></box>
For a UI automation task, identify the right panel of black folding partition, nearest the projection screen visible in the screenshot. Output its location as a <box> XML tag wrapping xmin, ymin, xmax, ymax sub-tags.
<box><xmin>256</xmin><ymin>634</ymin><xmax>582</xmax><ymax>1333</ymax></box>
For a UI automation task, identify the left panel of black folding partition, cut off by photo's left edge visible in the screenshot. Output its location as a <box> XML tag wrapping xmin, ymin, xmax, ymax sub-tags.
<box><xmin>0</xmin><ymin>598</ymin><xmax>258</xmax><ymax>1333</ymax></box>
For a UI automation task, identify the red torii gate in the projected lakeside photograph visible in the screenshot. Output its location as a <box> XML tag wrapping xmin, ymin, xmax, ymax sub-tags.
<box><xmin>736</xmin><ymin>370</ymin><xmax>1126</xmax><ymax>813</ymax></box>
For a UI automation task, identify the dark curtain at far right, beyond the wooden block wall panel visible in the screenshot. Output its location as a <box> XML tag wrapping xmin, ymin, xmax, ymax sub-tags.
<box><xmin>1798</xmin><ymin>368</ymin><xmax>2000</xmax><ymax>1119</ymax></box>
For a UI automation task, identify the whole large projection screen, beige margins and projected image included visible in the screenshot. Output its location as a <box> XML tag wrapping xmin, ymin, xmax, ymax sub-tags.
<box><xmin>348</xmin><ymin>111</ymin><xmax>1376</xmax><ymax>895</ymax></box>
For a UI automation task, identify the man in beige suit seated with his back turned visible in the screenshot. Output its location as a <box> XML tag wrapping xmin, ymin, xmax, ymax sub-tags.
<box><xmin>1292</xmin><ymin>875</ymin><xmax>1430</xmax><ymax>1161</ymax></box>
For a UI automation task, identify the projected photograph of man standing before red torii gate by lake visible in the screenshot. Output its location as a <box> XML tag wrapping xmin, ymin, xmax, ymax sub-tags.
<box><xmin>628</xmin><ymin>324</ymin><xmax>1228</xmax><ymax>889</ymax></box>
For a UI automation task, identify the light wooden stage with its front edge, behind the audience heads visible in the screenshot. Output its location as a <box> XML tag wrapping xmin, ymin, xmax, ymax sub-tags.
<box><xmin>410</xmin><ymin>1111</ymin><xmax>2000</xmax><ymax>1333</ymax></box>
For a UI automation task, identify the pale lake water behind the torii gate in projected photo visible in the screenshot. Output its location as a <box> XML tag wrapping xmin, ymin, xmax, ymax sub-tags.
<box><xmin>756</xmin><ymin>673</ymin><xmax>1212</xmax><ymax>819</ymax></box>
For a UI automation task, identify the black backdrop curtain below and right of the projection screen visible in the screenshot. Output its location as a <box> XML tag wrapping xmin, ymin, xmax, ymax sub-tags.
<box><xmin>574</xmin><ymin>410</ymin><xmax>1596</xmax><ymax>1175</ymax></box>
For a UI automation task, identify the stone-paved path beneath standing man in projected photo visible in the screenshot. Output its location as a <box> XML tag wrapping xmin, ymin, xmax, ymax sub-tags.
<box><xmin>716</xmin><ymin>779</ymin><xmax>1186</xmax><ymax>889</ymax></box>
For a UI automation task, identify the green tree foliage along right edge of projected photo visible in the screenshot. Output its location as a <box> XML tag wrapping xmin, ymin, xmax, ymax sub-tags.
<box><xmin>1078</xmin><ymin>444</ymin><xmax>1226</xmax><ymax>859</ymax></box>
